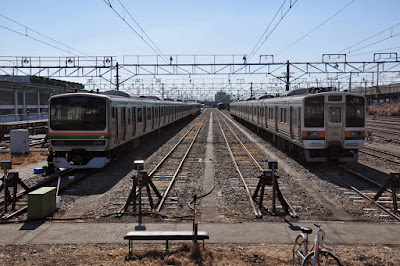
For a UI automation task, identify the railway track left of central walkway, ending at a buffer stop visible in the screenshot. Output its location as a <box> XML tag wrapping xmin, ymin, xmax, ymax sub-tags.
<box><xmin>119</xmin><ymin>112</ymin><xmax>209</xmax><ymax>216</ymax></box>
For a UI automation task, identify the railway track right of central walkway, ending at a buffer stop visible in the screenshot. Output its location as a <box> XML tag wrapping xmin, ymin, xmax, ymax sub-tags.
<box><xmin>217</xmin><ymin>111</ymin><xmax>297</xmax><ymax>217</ymax></box>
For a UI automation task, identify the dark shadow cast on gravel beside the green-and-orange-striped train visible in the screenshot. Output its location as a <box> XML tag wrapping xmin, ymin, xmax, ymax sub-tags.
<box><xmin>63</xmin><ymin>116</ymin><xmax>197</xmax><ymax>196</ymax></box>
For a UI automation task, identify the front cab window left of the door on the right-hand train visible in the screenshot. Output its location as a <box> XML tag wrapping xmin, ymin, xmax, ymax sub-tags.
<box><xmin>304</xmin><ymin>96</ymin><xmax>325</xmax><ymax>127</ymax></box>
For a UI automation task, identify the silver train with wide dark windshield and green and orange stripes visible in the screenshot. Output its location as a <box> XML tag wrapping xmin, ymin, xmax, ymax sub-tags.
<box><xmin>48</xmin><ymin>91</ymin><xmax>201</xmax><ymax>168</ymax></box>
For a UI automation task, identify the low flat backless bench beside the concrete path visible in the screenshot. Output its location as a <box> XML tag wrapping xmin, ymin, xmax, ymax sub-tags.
<box><xmin>124</xmin><ymin>231</ymin><xmax>210</xmax><ymax>259</ymax></box>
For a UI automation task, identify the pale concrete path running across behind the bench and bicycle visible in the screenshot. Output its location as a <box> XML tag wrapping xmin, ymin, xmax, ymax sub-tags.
<box><xmin>0</xmin><ymin>221</ymin><xmax>400</xmax><ymax>245</ymax></box>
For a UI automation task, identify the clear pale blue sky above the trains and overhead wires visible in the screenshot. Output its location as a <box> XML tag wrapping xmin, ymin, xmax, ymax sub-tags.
<box><xmin>0</xmin><ymin>0</ymin><xmax>400</xmax><ymax>100</ymax></box>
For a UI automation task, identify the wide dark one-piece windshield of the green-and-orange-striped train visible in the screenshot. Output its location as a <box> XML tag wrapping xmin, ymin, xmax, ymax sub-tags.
<box><xmin>50</xmin><ymin>96</ymin><xmax>106</xmax><ymax>130</ymax></box>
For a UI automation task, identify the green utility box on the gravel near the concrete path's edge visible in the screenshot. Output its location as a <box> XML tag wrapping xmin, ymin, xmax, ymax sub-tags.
<box><xmin>28</xmin><ymin>187</ymin><xmax>56</xmax><ymax>220</ymax></box>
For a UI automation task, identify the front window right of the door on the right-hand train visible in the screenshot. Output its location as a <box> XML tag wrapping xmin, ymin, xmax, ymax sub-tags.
<box><xmin>346</xmin><ymin>95</ymin><xmax>365</xmax><ymax>127</ymax></box>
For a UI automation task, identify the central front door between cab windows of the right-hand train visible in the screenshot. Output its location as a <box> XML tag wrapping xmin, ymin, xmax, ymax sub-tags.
<box><xmin>325</xmin><ymin>103</ymin><xmax>345</xmax><ymax>146</ymax></box>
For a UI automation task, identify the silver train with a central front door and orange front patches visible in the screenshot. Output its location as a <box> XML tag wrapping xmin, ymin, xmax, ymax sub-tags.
<box><xmin>230</xmin><ymin>91</ymin><xmax>366</xmax><ymax>162</ymax></box>
